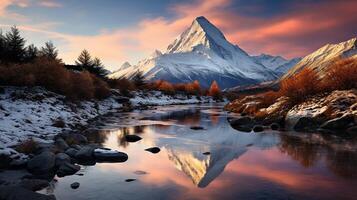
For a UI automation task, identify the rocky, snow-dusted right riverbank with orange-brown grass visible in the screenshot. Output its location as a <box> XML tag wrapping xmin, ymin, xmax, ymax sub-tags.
<box><xmin>225</xmin><ymin>90</ymin><xmax>357</xmax><ymax>135</ymax></box>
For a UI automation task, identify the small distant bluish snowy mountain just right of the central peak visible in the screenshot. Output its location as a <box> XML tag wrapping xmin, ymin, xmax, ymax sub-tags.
<box><xmin>253</xmin><ymin>54</ymin><xmax>301</xmax><ymax>76</ymax></box>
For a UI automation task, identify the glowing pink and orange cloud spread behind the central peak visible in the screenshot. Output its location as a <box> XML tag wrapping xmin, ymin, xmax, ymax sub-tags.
<box><xmin>0</xmin><ymin>0</ymin><xmax>357</xmax><ymax>69</ymax></box>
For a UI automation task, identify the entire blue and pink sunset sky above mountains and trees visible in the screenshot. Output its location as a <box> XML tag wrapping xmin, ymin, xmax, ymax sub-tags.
<box><xmin>0</xmin><ymin>0</ymin><xmax>357</xmax><ymax>70</ymax></box>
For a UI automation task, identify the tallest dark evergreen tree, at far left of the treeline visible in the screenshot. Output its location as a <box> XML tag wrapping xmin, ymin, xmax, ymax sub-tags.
<box><xmin>4</xmin><ymin>26</ymin><xmax>26</xmax><ymax>63</ymax></box>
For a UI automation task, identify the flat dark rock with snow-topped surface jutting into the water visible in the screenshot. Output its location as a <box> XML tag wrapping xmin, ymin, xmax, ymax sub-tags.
<box><xmin>94</xmin><ymin>148</ymin><xmax>128</xmax><ymax>162</ymax></box>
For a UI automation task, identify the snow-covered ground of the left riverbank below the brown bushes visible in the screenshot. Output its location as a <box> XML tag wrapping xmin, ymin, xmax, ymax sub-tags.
<box><xmin>0</xmin><ymin>87</ymin><xmax>211</xmax><ymax>155</ymax></box>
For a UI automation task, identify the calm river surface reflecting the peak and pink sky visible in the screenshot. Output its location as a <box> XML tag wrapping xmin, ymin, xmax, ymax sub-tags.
<box><xmin>42</xmin><ymin>105</ymin><xmax>357</xmax><ymax>200</ymax></box>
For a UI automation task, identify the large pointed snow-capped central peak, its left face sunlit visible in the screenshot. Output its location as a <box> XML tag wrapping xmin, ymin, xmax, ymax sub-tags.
<box><xmin>110</xmin><ymin>17</ymin><xmax>277</xmax><ymax>88</ymax></box>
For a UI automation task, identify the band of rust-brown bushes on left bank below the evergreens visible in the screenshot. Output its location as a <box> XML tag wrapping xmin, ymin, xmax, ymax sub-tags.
<box><xmin>0</xmin><ymin>58</ymin><xmax>110</xmax><ymax>100</ymax></box>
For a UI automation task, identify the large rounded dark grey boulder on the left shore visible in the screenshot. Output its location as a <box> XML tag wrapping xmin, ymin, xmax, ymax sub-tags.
<box><xmin>27</xmin><ymin>151</ymin><xmax>56</xmax><ymax>175</ymax></box>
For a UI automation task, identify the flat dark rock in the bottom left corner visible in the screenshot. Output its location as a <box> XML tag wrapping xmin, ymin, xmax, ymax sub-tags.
<box><xmin>0</xmin><ymin>186</ymin><xmax>56</xmax><ymax>200</ymax></box>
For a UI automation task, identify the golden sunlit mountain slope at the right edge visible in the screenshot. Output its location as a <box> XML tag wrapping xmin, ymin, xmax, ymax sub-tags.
<box><xmin>282</xmin><ymin>38</ymin><xmax>357</xmax><ymax>79</ymax></box>
